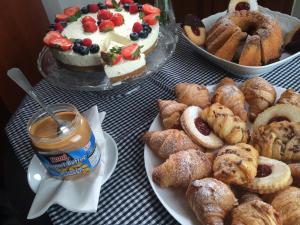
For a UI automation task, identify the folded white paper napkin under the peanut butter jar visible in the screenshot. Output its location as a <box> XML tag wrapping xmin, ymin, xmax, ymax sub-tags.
<box><xmin>27</xmin><ymin>106</ymin><xmax>106</xmax><ymax>219</ymax></box>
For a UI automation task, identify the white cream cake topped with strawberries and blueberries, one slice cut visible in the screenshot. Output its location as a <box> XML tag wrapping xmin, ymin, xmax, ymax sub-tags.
<box><xmin>44</xmin><ymin>0</ymin><xmax>160</xmax><ymax>82</ymax></box>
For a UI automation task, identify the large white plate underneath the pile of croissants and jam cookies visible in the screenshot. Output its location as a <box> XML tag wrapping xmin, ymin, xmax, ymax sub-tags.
<box><xmin>144</xmin><ymin>85</ymin><xmax>285</xmax><ymax>225</ymax></box>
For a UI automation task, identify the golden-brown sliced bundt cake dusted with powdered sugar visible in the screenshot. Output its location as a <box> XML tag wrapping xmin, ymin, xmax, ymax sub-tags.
<box><xmin>205</xmin><ymin>10</ymin><xmax>283</xmax><ymax>66</ymax></box>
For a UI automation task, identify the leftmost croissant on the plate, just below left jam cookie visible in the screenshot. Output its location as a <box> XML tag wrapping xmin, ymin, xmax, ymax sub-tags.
<box><xmin>143</xmin><ymin>129</ymin><xmax>201</xmax><ymax>159</ymax></box>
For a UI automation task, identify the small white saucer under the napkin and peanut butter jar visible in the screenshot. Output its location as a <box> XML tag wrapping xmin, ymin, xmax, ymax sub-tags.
<box><xmin>27</xmin><ymin>132</ymin><xmax>118</xmax><ymax>193</ymax></box>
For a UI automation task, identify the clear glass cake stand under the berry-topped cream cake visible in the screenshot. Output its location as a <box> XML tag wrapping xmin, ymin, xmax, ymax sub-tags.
<box><xmin>37</xmin><ymin>24</ymin><xmax>178</xmax><ymax>91</ymax></box>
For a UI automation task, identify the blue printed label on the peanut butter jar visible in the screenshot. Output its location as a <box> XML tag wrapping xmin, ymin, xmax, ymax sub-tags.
<box><xmin>36</xmin><ymin>133</ymin><xmax>100</xmax><ymax>177</ymax></box>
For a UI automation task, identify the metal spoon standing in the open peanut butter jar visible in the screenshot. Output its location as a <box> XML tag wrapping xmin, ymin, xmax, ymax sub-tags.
<box><xmin>7</xmin><ymin>68</ymin><xmax>69</xmax><ymax>134</ymax></box>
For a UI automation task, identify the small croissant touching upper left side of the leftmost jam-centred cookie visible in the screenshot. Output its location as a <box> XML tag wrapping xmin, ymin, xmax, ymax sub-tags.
<box><xmin>158</xmin><ymin>99</ymin><xmax>187</xmax><ymax>129</ymax></box>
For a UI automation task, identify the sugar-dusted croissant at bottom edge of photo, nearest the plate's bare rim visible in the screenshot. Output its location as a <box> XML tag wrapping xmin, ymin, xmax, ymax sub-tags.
<box><xmin>186</xmin><ymin>178</ymin><xmax>238</xmax><ymax>225</ymax></box>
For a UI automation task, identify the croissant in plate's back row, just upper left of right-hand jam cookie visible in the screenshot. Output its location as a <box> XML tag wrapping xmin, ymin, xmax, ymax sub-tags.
<box><xmin>240</xmin><ymin>77</ymin><xmax>276</xmax><ymax>121</ymax></box>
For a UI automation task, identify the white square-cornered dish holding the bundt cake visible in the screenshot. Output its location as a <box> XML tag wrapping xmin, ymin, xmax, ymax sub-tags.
<box><xmin>183</xmin><ymin>6</ymin><xmax>300</xmax><ymax>78</ymax></box>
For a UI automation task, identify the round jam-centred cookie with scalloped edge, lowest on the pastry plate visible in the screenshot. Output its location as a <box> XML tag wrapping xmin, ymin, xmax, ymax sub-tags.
<box><xmin>244</xmin><ymin>156</ymin><xmax>293</xmax><ymax>194</ymax></box>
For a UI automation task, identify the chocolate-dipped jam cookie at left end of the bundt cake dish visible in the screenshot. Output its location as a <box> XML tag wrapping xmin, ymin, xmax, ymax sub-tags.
<box><xmin>183</xmin><ymin>14</ymin><xmax>206</xmax><ymax>46</ymax></box>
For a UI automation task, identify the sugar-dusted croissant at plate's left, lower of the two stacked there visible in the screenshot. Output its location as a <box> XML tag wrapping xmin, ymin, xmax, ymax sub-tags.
<box><xmin>152</xmin><ymin>149</ymin><xmax>212</xmax><ymax>188</ymax></box>
